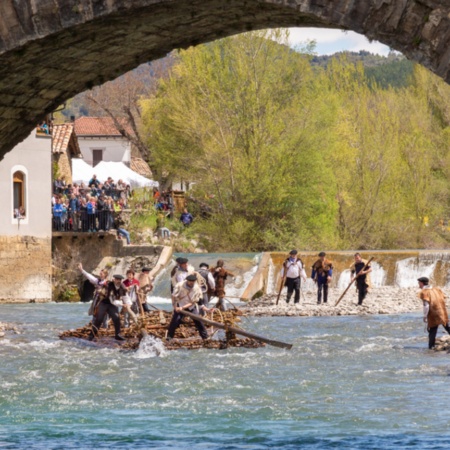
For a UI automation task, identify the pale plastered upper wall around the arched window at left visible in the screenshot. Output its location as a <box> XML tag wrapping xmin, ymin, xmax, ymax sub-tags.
<box><xmin>0</xmin><ymin>131</ymin><xmax>52</xmax><ymax>238</ymax></box>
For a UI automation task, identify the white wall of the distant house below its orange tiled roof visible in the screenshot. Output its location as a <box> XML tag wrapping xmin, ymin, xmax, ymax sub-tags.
<box><xmin>78</xmin><ymin>136</ymin><xmax>131</xmax><ymax>167</ymax></box>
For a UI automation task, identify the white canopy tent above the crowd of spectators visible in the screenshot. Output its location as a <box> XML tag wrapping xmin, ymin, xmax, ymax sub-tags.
<box><xmin>72</xmin><ymin>158</ymin><xmax>159</xmax><ymax>189</ymax></box>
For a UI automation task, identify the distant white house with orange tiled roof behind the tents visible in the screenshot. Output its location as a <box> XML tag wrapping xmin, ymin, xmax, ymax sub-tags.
<box><xmin>74</xmin><ymin>117</ymin><xmax>131</xmax><ymax>167</ymax></box>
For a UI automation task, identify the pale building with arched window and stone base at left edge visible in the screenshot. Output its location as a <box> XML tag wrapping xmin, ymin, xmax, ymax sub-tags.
<box><xmin>0</xmin><ymin>131</ymin><xmax>52</xmax><ymax>302</ymax></box>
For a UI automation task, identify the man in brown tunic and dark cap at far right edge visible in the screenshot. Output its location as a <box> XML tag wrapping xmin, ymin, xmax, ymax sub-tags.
<box><xmin>417</xmin><ymin>277</ymin><xmax>450</xmax><ymax>349</ymax></box>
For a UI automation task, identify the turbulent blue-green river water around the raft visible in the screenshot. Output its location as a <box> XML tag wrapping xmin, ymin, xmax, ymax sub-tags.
<box><xmin>0</xmin><ymin>304</ymin><xmax>450</xmax><ymax>450</ymax></box>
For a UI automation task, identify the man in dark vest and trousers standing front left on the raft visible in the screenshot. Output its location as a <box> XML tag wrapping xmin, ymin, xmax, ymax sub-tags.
<box><xmin>89</xmin><ymin>275</ymin><xmax>127</xmax><ymax>341</ymax></box>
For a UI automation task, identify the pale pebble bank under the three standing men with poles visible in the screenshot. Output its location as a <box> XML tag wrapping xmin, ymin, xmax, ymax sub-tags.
<box><xmin>242</xmin><ymin>286</ymin><xmax>442</xmax><ymax>317</ymax></box>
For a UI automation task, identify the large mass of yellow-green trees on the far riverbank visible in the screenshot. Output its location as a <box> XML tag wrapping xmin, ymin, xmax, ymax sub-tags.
<box><xmin>61</xmin><ymin>30</ymin><xmax>450</xmax><ymax>251</ymax></box>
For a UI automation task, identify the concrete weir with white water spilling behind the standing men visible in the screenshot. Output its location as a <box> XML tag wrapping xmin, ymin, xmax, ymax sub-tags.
<box><xmin>241</xmin><ymin>250</ymin><xmax>450</xmax><ymax>301</ymax></box>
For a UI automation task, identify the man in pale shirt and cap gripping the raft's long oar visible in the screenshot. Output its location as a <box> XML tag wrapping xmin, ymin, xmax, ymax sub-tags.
<box><xmin>167</xmin><ymin>274</ymin><xmax>209</xmax><ymax>340</ymax></box>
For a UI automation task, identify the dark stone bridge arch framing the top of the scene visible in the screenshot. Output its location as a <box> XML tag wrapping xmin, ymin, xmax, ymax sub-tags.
<box><xmin>0</xmin><ymin>0</ymin><xmax>450</xmax><ymax>159</ymax></box>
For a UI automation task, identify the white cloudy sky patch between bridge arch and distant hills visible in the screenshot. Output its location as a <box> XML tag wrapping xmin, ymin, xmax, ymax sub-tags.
<box><xmin>289</xmin><ymin>28</ymin><xmax>389</xmax><ymax>55</ymax></box>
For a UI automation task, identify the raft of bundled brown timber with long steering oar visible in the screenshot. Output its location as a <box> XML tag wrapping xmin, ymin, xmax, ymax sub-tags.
<box><xmin>59</xmin><ymin>310</ymin><xmax>292</xmax><ymax>350</ymax></box>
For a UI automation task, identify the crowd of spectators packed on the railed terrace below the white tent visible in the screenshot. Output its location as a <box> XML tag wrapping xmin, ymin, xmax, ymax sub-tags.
<box><xmin>52</xmin><ymin>175</ymin><xmax>132</xmax><ymax>243</ymax></box>
